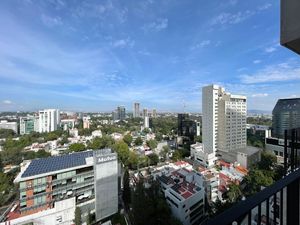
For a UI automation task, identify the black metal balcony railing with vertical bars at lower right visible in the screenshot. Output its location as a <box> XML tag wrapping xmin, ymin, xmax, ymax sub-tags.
<box><xmin>204</xmin><ymin>128</ymin><xmax>300</xmax><ymax>225</ymax></box>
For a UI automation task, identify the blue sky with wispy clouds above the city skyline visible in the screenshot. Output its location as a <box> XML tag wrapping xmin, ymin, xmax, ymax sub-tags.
<box><xmin>0</xmin><ymin>0</ymin><xmax>300</xmax><ymax>112</ymax></box>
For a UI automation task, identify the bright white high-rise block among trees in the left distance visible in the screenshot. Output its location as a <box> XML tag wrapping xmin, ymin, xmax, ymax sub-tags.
<box><xmin>39</xmin><ymin>109</ymin><xmax>60</xmax><ymax>133</ymax></box>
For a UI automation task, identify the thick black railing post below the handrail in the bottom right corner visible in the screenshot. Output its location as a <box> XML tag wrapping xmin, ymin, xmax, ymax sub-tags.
<box><xmin>286</xmin><ymin>180</ymin><xmax>299</xmax><ymax>225</ymax></box>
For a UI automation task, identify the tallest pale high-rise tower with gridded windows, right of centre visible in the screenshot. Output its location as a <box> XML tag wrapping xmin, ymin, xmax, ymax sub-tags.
<box><xmin>202</xmin><ymin>85</ymin><xmax>247</xmax><ymax>165</ymax></box>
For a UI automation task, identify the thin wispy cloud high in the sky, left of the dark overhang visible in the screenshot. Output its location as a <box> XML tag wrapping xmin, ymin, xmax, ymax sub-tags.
<box><xmin>211</xmin><ymin>10</ymin><xmax>255</xmax><ymax>25</ymax></box>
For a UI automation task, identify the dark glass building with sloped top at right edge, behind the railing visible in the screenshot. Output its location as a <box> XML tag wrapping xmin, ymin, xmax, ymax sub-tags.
<box><xmin>272</xmin><ymin>98</ymin><xmax>300</xmax><ymax>138</ymax></box>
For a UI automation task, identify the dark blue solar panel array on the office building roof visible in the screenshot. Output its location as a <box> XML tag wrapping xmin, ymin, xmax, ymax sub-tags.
<box><xmin>22</xmin><ymin>151</ymin><xmax>93</xmax><ymax>177</ymax></box>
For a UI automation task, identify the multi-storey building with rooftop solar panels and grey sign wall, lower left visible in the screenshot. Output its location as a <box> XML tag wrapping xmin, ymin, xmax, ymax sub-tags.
<box><xmin>8</xmin><ymin>149</ymin><xmax>118</xmax><ymax>224</ymax></box>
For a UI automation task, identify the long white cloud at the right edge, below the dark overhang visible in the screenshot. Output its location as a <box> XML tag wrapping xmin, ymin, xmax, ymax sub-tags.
<box><xmin>240</xmin><ymin>62</ymin><xmax>300</xmax><ymax>84</ymax></box>
